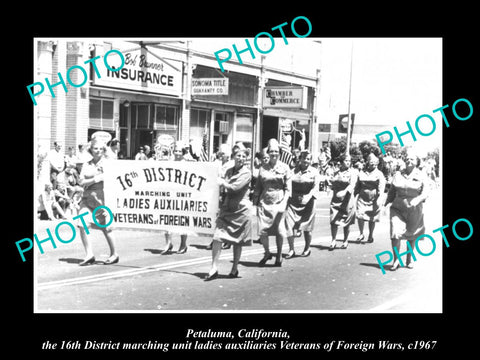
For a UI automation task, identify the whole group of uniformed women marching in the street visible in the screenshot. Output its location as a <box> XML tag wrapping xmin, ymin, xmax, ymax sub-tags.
<box><xmin>74</xmin><ymin>139</ymin><xmax>428</xmax><ymax>281</ymax></box>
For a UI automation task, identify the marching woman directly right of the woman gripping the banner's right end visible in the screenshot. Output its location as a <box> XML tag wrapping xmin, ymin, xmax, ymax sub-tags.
<box><xmin>253</xmin><ymin>139</ymin><xmax>292</xmax><ymax>266</ymax></box>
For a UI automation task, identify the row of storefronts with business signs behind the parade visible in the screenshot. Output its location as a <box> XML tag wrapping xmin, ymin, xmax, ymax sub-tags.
<box><xmin>35</xmin><ymin>39</ymin><xmax>321</xmax><ymax>159</ymax></box>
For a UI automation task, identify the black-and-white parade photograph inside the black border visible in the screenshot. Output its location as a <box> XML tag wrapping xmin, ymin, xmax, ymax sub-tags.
<box><xmin>31</xmin><ymin>36</ymin><xmax>442</xmax><ymax>313</ymax></box>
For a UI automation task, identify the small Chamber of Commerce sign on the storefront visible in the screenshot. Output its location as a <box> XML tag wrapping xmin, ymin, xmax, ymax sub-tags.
<box><xmin>263</xmin><ymin>86</ymin><xmax>307</xmax><ymax>109</ymax></box>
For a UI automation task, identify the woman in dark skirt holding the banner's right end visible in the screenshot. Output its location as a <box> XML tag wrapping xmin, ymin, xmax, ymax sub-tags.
<box><xmin>205</xmin><ymin>147</ymin><xmax>252</xmax><ymax>281</ymax></box>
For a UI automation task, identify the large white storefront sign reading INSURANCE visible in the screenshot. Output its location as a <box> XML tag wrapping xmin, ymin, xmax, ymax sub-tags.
<box><xmin>93</xmin><ymin>48</ymin><xmax>182</xmax><ymax>96</ymax></box>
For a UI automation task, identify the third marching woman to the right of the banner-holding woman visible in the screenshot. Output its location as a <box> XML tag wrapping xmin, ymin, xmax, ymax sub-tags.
<box><xmin>330</xmin><ymin>154</ymin><xmax>358</xmax><ymax>250</ymax></box>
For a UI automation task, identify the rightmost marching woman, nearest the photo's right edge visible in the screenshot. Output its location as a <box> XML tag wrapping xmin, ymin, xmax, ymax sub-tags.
<box><xmin>385</xmin><ymin>149</ymin><xmax>429</xmax><ymax>271</ymax></box>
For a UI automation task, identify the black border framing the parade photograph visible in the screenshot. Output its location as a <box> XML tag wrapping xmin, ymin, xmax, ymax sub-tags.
<box><xmin>9</xmin><ymin>3</ymin><xmax>480</xmax><ymax>357</ymax></box>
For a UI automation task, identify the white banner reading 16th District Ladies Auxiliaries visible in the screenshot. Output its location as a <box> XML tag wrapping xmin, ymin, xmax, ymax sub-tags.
<box><xmin>104</xmin><ymin>160</ymin><xmax>219</xmax><ymax>234</ymax></box>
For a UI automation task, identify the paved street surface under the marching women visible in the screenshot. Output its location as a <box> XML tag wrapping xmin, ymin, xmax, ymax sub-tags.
<box><xmin>34</xmin><ymin>189</ymin><xmax>442</xmax><ymax>312</ymax></box>
